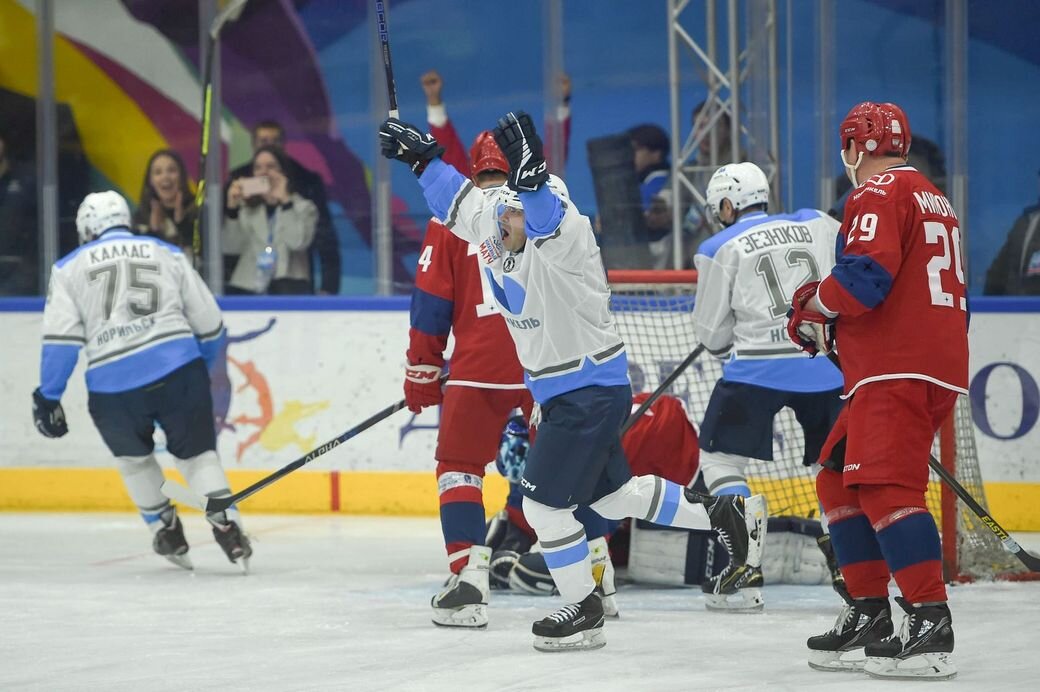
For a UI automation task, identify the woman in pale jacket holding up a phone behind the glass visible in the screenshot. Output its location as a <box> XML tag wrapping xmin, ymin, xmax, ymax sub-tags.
<box><xmin>224</xmin><ymin>147</ymin><xmax>318</xmax><ymax>294</ymax></box>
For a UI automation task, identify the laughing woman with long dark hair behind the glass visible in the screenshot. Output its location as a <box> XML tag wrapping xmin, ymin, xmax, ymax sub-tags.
<box><xmin>133</xmin><ymin>149</ymin><xmax>199</xmax><ymax>259</ymax></box>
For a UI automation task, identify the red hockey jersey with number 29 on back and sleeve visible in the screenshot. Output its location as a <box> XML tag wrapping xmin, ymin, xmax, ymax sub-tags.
<box><xmin>817</xmin><ymin>165</ymin><xmax>968</xmax><ymax>394</ymax></box>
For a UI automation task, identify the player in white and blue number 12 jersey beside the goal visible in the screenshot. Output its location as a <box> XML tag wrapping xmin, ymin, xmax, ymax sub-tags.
<box><xmin>694</xmin><ymin>162</ymin><xmax>842</xmax><ymax>610</ymax></box>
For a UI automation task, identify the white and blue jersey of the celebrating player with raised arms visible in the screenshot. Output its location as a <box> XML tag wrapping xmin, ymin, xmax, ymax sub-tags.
<box><xmin>419</xmin><ymin>159</ymin><xmax>628</xmax><ymax>403</ymax></box>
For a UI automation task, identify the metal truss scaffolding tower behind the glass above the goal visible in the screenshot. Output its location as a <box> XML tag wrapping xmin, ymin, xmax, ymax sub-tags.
<box><xmin>667</xmin><ymin>0</ymin><xmax>782</xmax><ymax>268</ymax></box>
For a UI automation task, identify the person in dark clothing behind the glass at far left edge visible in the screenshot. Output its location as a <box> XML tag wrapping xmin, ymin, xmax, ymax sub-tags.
<box><xmin>0</xmin><ymin>130</ymin><xmax>40</xmax><ymax>296</ymax></box>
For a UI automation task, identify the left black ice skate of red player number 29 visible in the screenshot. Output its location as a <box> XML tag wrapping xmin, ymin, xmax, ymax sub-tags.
<box><xmin>806</xmin><ymin>596</ymin><xmax>892</xmax><ymax>671</ymax></box>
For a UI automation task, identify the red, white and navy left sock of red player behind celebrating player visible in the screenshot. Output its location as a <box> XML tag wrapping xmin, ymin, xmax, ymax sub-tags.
<box><xmin>437</xmin><ymin>462</ymin><xmax>486</xmax><ymax>574</ymax></box>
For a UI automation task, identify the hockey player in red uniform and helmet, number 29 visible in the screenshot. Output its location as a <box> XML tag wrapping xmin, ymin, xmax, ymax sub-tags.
<box><xmin>788</xmin><ymin>102</ymin><xmax>968</xmax><ymax>678</ymax></box>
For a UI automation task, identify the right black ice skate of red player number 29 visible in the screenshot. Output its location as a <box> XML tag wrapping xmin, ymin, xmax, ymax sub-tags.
<box><xmin>863</xmin><ymin>596</ymin><xmax>957</xmax><ymax>680</ymax></box>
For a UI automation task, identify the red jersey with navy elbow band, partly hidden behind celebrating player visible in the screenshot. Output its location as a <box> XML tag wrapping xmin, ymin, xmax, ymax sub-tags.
<box><xmin>408</xmin><ymin>220</ymin><xmax>523</xmax><ymax>389</ymax></box>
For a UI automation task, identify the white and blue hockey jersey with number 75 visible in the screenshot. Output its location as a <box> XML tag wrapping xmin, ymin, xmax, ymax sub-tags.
<box><xmin>40</xmin><ymin>228</ymin><xmax>224</xmax><ymax>400</ymax></box>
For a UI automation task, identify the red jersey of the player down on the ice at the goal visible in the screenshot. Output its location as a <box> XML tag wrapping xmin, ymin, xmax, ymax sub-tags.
<box><xmin>621</xmin><ymin>392</ymin><xmax>701</xmax><ymax>485</ymax></box>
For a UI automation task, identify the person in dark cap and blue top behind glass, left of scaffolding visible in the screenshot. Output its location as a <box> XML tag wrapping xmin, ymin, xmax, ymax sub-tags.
<box><xmin>628</xmin><ymin>124</ymin><xmax>672</xmax><ymax>270</ymax></box>
